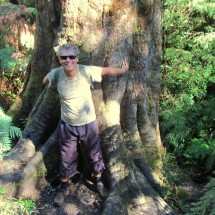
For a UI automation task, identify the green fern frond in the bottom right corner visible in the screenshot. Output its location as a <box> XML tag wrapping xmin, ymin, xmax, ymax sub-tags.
<box><xmin>188</xmin><ymin>178</ymin><xmax>215</xmax><ymax>215</ymax></box>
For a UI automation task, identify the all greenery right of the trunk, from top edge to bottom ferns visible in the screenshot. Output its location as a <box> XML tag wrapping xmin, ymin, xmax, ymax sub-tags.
<box><xmin>159</xmin><ymin>0</ymin><xmax>215</xmax><ymax>215</ymax></box>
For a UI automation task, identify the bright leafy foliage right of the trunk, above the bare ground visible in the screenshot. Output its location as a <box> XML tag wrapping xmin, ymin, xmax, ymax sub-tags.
<box><xmin>160</xmin><ymin>0</ymin><xmax>215</xmax><ymax>171</ymax></box>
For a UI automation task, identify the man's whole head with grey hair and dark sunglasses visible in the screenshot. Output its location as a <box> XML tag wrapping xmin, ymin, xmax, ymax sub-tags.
<box><xmin>57</xmin><ymin>44</ymin><xmax>79</xmax><ymax>72</ymax></box>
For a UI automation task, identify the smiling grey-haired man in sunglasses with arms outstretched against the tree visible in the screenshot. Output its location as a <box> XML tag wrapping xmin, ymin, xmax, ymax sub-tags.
<box><xmin>43</xmin><ymin>44</ymin><xmax>128</xmax><ymax>206</ymax></box>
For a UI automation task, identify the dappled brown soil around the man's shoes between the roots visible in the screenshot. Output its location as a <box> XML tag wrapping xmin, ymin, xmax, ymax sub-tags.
<box><xmin>37</xmin><ymin>183</ymin><xmax>103</xmax><ymax>215</ymax></box>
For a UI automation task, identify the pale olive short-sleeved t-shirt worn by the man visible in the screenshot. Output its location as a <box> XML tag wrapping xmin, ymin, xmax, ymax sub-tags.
<box><xmin>48</xmin><ymin>64</ymin><xmax>102</xmax><ymax>126</ymax></box>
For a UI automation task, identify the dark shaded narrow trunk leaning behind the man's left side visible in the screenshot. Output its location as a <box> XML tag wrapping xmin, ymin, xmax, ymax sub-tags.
<box><xmin>8</xmin><ymin>1</ymin><xmax>55</xmax><ymax>126</ymax></box>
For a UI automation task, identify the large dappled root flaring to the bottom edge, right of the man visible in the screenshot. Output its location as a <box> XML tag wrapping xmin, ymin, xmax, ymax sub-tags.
<box><xmin>103</xmin><ymin>126</ymin><xmax>175</xmax><ymax>215</ymax></box>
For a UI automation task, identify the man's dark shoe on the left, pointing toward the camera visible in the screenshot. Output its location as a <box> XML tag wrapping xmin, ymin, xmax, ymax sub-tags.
<box><xmin>53</xmin><ymin>182</ymin><xmax>69</xmax><ymax>207</ymax></box>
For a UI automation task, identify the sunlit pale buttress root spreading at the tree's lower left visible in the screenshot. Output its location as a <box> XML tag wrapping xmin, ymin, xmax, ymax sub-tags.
<box><xmin>0</xmin><ymin>130</ymin><xmax>59</xmax><ymax>198</ymax></box>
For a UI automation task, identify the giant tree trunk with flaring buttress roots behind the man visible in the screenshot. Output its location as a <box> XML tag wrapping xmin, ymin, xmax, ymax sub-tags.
<box><xmin>0</xmin><ymin>0</ymin><xmax>174</xmax><ymax>215</ymax></box>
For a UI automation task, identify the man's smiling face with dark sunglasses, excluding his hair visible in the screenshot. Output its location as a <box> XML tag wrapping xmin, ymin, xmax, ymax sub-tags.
<box><xmin>59</xmin><ymin>49</ymin><xmax>78</xmax><ymax>72</ymax></box>
